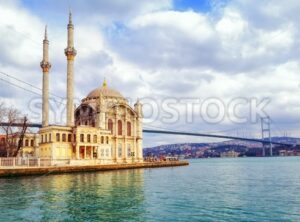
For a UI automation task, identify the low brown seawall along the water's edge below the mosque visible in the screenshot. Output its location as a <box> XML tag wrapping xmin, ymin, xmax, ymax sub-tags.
<box><xmin>0</xmin><ymin>161</ymin><xmax>189</xmax><ymax>177</ymax></box>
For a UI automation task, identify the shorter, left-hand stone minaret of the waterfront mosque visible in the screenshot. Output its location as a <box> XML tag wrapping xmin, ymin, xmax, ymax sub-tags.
<box><xmin>41</xmin><ymin>26</ymin><xmax>51</xmax><ymax>127</ymax></box>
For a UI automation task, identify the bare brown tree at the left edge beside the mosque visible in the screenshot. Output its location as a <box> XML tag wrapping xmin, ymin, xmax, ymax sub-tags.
<box><xmin>0</xmin><ymin>103</ymin><xmax>27</xmax><ymax>157</ymax></box>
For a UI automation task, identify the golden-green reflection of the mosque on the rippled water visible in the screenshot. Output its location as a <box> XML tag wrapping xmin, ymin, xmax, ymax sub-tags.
<box><xmin>0</xmin><ymin>169</ymin><xmax>145</xmax><ymax>221</ymax></box>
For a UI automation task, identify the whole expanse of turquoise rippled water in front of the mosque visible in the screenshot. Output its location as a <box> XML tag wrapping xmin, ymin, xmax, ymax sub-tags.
<box><xmin>0</xmin><ymin>157</ymin><xmax>300</xmax><ymax>222</ymax></box>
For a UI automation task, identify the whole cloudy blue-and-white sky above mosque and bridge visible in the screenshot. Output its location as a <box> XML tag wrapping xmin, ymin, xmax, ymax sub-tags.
<box><xmin>0</xmin><ymin>0</ymin><xmax>300</xmax><ymax>147</ymax></box>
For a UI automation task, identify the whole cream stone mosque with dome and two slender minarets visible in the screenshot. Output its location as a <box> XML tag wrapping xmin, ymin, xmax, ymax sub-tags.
<box><xmin>27</xmin><ymin>13</ymin><xmax>143</xmax><ymax>164</ymax></box>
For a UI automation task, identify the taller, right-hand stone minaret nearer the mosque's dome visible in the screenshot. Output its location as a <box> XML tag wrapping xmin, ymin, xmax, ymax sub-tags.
<box><xmin>65</xmin><ymin>12</ymin><xmax>77</xmax><ymax>126</ymax></box>
